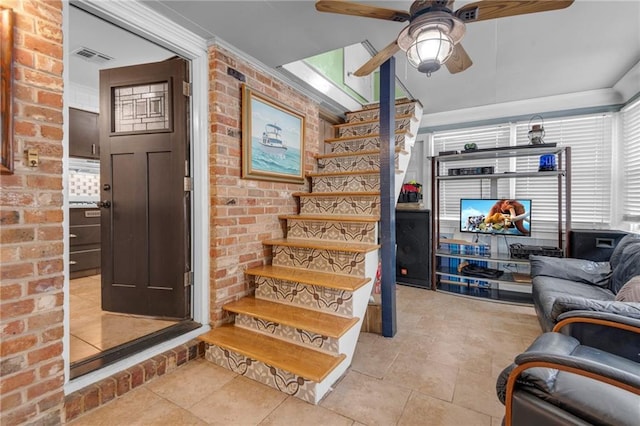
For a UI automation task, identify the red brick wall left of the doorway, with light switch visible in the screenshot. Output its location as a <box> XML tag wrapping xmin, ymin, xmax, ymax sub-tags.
<box><xmin>0</xmin><ymin>0</ymin><xmax>64</xmax><ymax>425</ymax></box>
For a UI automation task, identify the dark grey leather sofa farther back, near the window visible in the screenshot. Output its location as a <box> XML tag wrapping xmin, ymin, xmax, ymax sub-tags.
<box><xmin>530</xmin><ymin>234</ymin><xmax>640</xmax><ymax>332</ymax></box>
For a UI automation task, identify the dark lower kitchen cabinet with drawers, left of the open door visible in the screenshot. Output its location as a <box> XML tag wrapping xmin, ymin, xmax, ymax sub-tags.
<box><xmin>69</xmin><ymin>208</ymin><xmax>100</xmax><ymax>279</ymax></box>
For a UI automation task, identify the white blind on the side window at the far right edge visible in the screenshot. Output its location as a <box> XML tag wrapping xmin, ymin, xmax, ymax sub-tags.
<box><xmin>622</xmin><ymin>99</ymin><xmax>640</xmax><ymax>222</ymax></box>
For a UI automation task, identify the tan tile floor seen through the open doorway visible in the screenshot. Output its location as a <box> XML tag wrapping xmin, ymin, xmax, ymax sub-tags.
<box><xmin>69</xmin><ymin>275</ymin><xmax>176</xmax><ymax>362</ymax></box>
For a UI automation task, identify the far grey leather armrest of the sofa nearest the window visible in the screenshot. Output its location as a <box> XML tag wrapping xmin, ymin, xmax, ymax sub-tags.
<box><xmin>529</xmin><ymin>255</ymin><xmax>611</xmax><ymax>287</ymax></box>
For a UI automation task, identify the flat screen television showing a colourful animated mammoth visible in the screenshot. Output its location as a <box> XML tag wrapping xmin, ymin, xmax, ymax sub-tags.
<box><xmin>460</xmin><ymin>198</ymin><xmax>531</xmax><ymax>237</ymax></box>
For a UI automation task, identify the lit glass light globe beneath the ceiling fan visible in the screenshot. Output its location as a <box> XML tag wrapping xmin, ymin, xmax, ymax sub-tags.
<box><xmin>407</xmin><ymin>28</ymin><xmax>454</xmax><ymax>74</ymax></box>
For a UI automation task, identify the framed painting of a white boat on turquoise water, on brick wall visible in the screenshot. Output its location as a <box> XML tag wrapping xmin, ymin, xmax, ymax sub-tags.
<box><xmin>242</xmin><ymin>84</ymin><xmax>305</xmax><ymax>183</ymax></box>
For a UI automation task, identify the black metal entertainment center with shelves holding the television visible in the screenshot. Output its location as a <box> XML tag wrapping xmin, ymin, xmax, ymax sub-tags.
<box><xmin>431</xmin><ymin>144</ymin><xmax>571</xmax><ymax>304</ymax></box>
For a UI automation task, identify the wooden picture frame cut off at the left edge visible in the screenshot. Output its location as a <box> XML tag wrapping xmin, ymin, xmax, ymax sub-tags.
<box><xmin>0</xmin><ymin>8</ymin><xmax>14</xmax><ymax>175</ymax></box>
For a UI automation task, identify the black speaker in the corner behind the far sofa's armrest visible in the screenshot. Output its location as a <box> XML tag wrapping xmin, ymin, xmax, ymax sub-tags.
<box><xmin>569</xmin><ymin>229</ymin><xmax>627</xmax><ymax>262</ymax></box>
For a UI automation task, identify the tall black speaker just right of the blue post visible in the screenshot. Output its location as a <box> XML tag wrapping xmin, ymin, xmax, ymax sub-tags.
<box><xmin>396</xmin><ymin>210</ymin><xmax>431</xmax><ymax>288</ymax></box>
